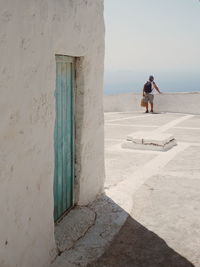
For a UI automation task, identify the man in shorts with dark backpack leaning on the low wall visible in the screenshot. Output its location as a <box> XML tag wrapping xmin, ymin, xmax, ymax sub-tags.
<box><xmin>143</xmin><ymin>75</ymin><xmax>161</xmax><ymax>113</ymax></box>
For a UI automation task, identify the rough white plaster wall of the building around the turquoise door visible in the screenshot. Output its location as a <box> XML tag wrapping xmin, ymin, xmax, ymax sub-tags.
<box><xmin>0</xmin><ymin>0</ymin><xmax>104</xmax><ymax>267</ymax></box>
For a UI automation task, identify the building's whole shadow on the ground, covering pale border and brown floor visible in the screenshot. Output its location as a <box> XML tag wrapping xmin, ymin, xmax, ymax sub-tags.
<box><xmin>51</xmin><ymin>194</ymin><xmax>194</xmax><ymax>267</ymax></box>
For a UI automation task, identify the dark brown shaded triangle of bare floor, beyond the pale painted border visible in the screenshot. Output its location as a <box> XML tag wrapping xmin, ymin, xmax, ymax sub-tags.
<box><xmin>87</xmin><ymin>210</ymin><xmax>194</xmax><ymax>267</ymax></box>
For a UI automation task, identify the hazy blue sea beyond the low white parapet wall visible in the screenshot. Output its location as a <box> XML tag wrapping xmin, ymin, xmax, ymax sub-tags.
<box><xmin>104</xmin><ymin>70</ymin><xmax>200</xmax><ymax>95</ymax></box>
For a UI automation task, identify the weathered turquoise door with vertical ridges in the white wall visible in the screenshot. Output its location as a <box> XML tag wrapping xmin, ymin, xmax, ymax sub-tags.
<box><xmin>54</xmin><ymin>55</ymin><xmax>74</xmax><ymax>221</ymax></box>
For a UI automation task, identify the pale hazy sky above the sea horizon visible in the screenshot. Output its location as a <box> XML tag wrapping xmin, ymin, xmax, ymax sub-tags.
<box><xmin>105</xmin><ymin>0</ymin><xmax>200</xmax><ymax>73</ymax></box>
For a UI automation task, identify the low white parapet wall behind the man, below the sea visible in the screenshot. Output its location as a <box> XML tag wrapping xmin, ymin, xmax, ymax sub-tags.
<box><xmin>104</xmin><ymin>92</ymin><xmax>200</xmax><ymax>114</ymax></box>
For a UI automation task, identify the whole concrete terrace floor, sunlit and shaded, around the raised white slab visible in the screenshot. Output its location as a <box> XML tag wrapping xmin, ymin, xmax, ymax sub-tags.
<box><xmin>52</xmin><ymin>112</ymin><xmax>200</xmax><ymax>267</ymax></box>
